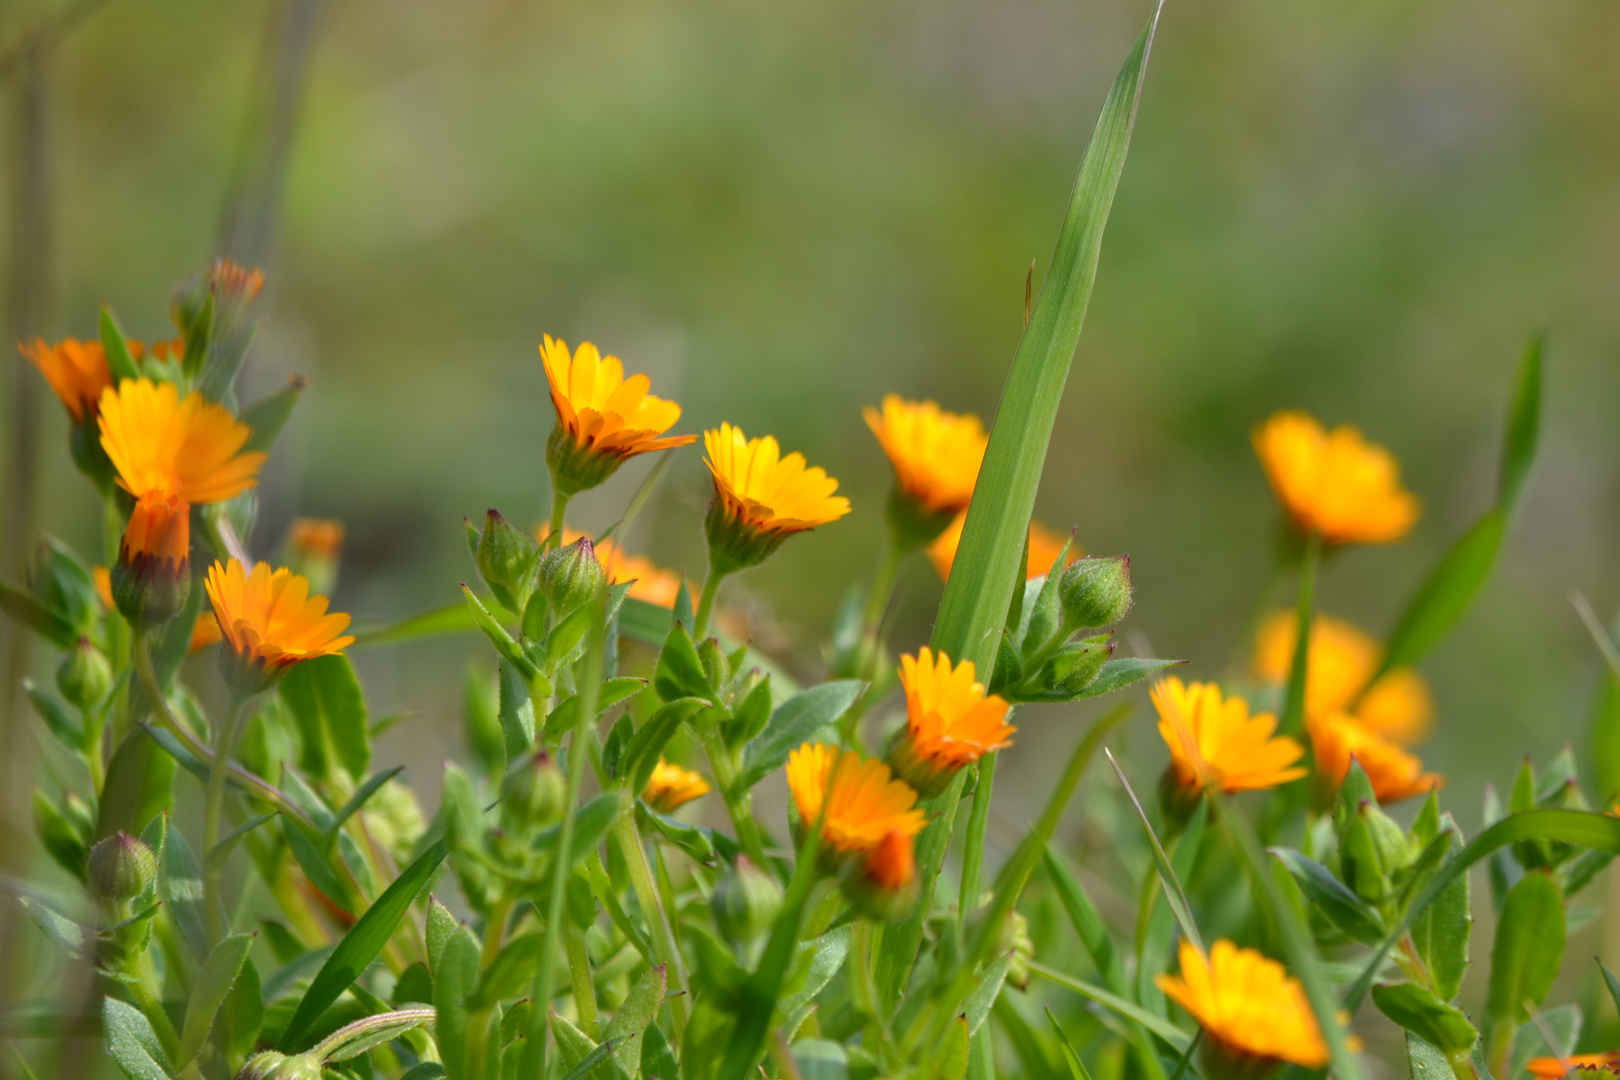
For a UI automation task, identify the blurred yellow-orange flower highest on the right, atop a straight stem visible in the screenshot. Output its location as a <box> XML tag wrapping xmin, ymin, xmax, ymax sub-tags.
<box><xmin>1254</xmin><ymin>413</ymin><xmax>1418</xmax><ymax>544</ymax></box>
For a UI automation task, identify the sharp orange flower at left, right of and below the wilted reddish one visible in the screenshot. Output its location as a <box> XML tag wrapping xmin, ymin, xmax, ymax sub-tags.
<box><xmin>207</xmin><ymin>559</ymin><xmax>355</xmax><ymax>693</ymax></box>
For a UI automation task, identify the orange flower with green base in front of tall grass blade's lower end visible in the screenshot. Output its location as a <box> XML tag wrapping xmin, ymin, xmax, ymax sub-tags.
<box><xmin>886</xmin><ymin>648</ymin><xmax>1017</xmax><ymax>797</ymax></box>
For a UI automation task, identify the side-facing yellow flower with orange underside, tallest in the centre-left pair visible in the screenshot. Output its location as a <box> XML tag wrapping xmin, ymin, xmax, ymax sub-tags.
<box><xmin>539</xmin><ymin>334</ymin><xmax>697</xmax><ymax>495</ymax></box>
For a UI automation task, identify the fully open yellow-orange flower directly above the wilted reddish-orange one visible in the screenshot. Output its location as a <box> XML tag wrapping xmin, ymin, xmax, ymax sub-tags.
<box><xmin>99</xmin><ymin>379</ymin><xmax>264</xmax><ymax>505</ymax></box>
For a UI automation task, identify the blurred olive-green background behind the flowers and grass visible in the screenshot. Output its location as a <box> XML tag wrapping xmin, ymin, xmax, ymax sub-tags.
<box><xmin>9</xmin><ymin>0</ymin><xmax>1620</xmax><ymax>893</ymax></box>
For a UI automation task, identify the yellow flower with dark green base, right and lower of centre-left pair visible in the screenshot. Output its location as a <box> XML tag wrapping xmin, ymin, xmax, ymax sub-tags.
<box><xmin>703</xmin><ymin>424</ymin><xmax>849</xmax><ymax>573</ymax></box>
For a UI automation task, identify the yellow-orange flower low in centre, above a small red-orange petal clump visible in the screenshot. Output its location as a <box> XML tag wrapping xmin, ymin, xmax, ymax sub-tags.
<box><xmin>787</xmin><ymin>743</ymin><xmax>927</xmax><ymax>855</ymax></box>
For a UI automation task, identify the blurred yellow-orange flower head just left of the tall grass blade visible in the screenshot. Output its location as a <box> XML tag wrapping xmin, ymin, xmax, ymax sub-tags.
<box><xmin>863</xmin><ymin>393</ymin><xmax>990</xmax><ymax>513</ymax></box>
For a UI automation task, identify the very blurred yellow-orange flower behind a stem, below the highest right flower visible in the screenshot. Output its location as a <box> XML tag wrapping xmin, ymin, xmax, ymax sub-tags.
<box><xmin>1254</xmin><ymin>610</ymin><xmax>1434</xmax><ymax>745</ymax></box>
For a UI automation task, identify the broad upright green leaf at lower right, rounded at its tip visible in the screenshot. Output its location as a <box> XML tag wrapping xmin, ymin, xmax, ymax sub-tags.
<box><xmin>1483</xmin><ymin>873</ymin><xmax>1565</xmax><ymax>1075</ymax></box>
